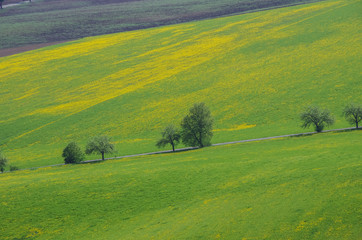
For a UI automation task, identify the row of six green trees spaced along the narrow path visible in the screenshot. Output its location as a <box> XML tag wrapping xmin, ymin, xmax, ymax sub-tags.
<box><xmin>62</xmin><ymin>103</ymin><xmax>362</xmax><ymax>163</ymax></box>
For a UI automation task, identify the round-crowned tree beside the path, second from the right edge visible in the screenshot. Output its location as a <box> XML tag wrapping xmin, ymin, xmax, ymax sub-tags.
<box><xmin>300</xmin><ymin>106</ymin><xmax>334</xmax><ymax>132</ymax></box>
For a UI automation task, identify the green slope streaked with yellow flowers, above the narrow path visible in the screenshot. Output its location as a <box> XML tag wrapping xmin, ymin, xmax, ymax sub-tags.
<box><xmin>0</xmin><ymin>0</ymin><xmax>362</xmax><ymax>167</ymax></box>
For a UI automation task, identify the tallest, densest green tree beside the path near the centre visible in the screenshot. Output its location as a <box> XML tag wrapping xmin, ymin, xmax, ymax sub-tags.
<box><xmin>181</xmin><ymin>103</ymin><xmax>213</xmax><ymax>147</ymax></box>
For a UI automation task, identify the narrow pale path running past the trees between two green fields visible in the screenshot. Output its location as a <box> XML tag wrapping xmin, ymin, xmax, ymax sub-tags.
<box><xmin>7</xmin><ymin>127</ymin><xmax>361</xmax><ymax>172</ymax></box>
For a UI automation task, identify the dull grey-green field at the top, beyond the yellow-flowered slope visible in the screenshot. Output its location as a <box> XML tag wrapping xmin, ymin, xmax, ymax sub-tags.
<box><xmin>0</xmin><ymin>0</ymin><xmax>315</xmax><ymax>49</ymax></box>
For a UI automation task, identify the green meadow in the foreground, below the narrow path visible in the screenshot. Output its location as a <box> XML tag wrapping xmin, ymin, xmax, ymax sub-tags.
<box><xmin>0</xmin><ymin>131</ymin><xmax>362</xmax><ymax>240</ymax></box>
